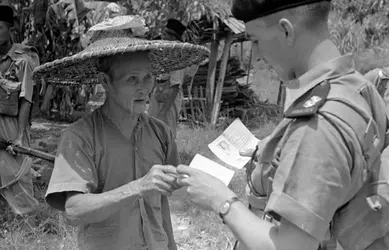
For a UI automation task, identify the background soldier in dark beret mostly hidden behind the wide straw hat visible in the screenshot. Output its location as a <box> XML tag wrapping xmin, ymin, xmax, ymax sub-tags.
<box><xmin>149</xmin><ymin>19</ymin><xmax>198</xmax><ymax>137</ymax></box>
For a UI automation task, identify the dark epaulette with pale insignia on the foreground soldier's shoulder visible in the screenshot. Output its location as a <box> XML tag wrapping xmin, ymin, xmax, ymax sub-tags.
<box><xmin>284</xmin><ymin>80</ymin><xmax>331</xmax><ymax>118</ymax></box>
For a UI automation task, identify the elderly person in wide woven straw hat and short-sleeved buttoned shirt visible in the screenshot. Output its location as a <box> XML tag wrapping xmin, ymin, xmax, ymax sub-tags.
<box><xmin>35</xmin><ymin>16</ymin><xmax>209</xmax><ymax>250</ymax></box>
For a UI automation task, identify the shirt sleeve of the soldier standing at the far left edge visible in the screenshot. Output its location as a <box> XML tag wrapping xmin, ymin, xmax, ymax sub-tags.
<box><xmin>18</xmin><ymin>52</ymin><xmax>39</xmax><ymax>102</ymax></box>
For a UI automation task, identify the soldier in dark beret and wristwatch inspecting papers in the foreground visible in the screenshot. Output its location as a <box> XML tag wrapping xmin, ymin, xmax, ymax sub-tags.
<box><xmin>177</xmin><ymin>0</ymin><xmax>389</xmax><ymax>250</ymax></box>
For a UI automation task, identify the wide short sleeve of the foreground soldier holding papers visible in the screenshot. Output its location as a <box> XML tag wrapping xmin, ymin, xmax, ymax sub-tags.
<box><xmin>265</xmin><ymin>117</ymin><xmax>352</xmax><ymax>242</ymax></box>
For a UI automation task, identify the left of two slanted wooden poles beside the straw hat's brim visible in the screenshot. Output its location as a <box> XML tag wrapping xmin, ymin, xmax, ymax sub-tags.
<box><xmin>206</xmin><ymin>18</ymin><xmax>219</xmax><ymax>122</ymax></box>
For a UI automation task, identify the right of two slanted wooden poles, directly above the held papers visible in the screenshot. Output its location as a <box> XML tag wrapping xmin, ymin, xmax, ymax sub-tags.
<box><xmin>211</xmin><ymin>31</ymin><xmax>232</xmax><ymax>127</ymax></box>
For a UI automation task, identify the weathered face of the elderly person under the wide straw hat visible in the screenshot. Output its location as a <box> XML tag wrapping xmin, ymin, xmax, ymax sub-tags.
<box><xmin>107</xmin><ymin>52</ymin><xmax>153</xmax><ymax>113</ymax></box>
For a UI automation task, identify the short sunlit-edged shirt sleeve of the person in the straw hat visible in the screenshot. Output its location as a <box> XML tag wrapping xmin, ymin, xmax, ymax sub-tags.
<box><xmin>46</xmin><ymin>129</ymin><xmax>98</xmax><ymax>211</ymax></box>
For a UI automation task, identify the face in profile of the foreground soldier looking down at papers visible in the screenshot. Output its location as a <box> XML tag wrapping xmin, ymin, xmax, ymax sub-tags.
<box><xmin>245</xmin><ymin>18</ymin><xmax>293</xmax><ymax>81</ymax></box>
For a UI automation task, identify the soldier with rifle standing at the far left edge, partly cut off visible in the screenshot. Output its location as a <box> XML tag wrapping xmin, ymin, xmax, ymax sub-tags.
<box><xmin>0</xmin><ymin>0</ymin><xmax>39</xmax><ymax>214</ymax></box>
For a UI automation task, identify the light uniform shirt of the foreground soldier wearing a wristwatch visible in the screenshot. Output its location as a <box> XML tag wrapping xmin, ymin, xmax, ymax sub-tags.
<box><xmin>248</xmin><ymin>55</ymin><xmax>389</xmax><ymax>250</ymax></box>
